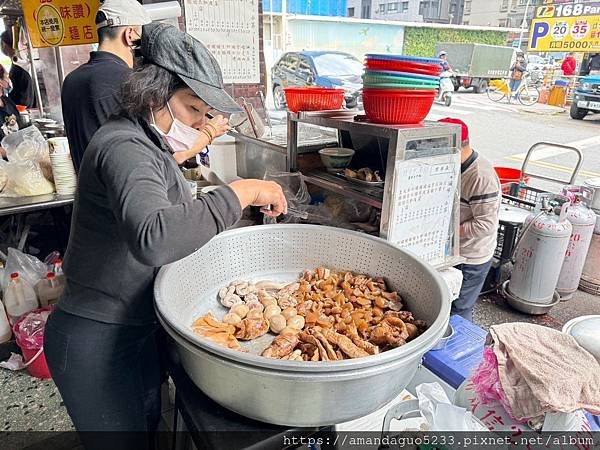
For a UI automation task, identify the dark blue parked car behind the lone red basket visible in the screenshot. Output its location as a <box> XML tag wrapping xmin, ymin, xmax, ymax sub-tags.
<box><xmin>271</xmin><ymin>51</ymin><xmax>363</xmax><ymax>109</ymax></box>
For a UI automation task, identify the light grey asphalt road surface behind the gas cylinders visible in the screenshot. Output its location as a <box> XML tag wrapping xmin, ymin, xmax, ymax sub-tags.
<box><xmin>428</xmin><ymin>90</ymin><xmax>600</xmax><ymax>188</ymax></box>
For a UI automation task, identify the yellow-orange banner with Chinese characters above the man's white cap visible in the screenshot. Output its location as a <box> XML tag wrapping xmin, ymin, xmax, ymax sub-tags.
<box><xmin>23</xmin><ymin>0</ymin><xmax>100</xmax><ymax>48</ymax></box>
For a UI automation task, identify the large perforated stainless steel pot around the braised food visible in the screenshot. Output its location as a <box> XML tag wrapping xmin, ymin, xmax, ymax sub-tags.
<box><xmin>155</xmin><ymin>225</ymin><xmax>450</xmax><ymax>426</ymax></box>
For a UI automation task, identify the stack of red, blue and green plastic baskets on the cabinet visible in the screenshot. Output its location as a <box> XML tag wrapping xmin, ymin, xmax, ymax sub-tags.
<box><xmin>363</xmin><ymin>54</ymin><xmax>442</xmax><ymax>124</ymax></box>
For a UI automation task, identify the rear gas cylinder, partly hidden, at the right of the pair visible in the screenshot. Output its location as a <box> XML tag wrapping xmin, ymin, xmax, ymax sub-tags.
<box><xmin>556</xmin><ymin>194</ymin><xmax>596</xmax><ymax>301</ymax></box>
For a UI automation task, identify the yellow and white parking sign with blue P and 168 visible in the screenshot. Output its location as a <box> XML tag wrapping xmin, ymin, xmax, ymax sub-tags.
<box><xmin>529</xmin><ymin>2</ymin><xmax>600</xmax><ymax>52</ymax></box>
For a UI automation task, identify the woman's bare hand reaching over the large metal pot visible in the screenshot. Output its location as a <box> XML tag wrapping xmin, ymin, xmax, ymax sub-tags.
<box><xmin>229</xmin><ymin>180</ymin><xmax>287</xmax><ymax>217</ymax></box>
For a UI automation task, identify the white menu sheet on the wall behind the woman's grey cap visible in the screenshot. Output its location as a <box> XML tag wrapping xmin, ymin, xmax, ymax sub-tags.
<box><xmin>184</xmin><ymin>0</ymin><xmax>260</xmax><ymax>84</ymax></box>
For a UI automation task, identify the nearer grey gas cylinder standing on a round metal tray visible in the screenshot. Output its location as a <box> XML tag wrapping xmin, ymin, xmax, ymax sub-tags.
<box><xmin>507</xmin><ymin>198</ymin><xmax>573</xmax><ymax>305</ymax></box>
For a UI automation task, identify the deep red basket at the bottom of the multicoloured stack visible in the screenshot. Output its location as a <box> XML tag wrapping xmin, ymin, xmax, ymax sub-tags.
<box><xmin>363</xmin><ymin>89</ymin><xmax>437</xmax><ymax>124</ymax></box>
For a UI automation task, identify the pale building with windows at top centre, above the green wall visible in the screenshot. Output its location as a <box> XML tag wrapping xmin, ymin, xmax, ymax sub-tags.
<box><xmin>347</xmin><ymin>0</ymin><xmax>465</xmax><ymax>24</ymax></box>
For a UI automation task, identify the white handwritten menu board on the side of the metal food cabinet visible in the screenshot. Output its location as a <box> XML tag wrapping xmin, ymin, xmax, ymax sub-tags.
<box><xmin>388</xmin><ymin>154</ymin><xmax>460</xmax><ymax>264</ymax></box>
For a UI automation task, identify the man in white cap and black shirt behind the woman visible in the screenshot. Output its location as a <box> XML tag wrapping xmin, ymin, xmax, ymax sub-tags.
<box><xmin>62</xmin><ymin>0</ymin><xmax>151</xmax><ymax>171</ymax></box>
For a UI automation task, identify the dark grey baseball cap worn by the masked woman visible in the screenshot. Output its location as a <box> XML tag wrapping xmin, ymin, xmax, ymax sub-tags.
<box><xmin>141</xmin><ymin>22</ymin><xmax>242</xmax><ymax>113</ymax></box>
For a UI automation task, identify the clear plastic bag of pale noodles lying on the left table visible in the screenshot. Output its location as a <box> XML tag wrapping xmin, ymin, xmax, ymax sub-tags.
<box><xmin>0</xmin><ymin>161</ymin><xmax>54</xmax><ymax>197</ymax></box>
